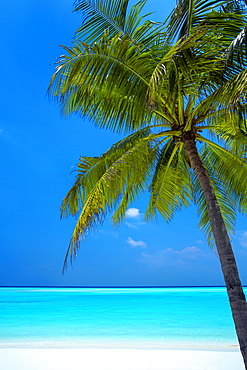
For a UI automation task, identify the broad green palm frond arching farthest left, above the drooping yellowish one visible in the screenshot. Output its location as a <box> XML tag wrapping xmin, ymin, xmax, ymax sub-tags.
<box><xmin>48</xmin><ymin>35</ymin><xmax>159</xmax><ymax>131</ymax></box>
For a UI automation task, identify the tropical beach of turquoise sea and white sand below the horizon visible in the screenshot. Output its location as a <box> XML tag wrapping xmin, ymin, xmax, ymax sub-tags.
<box><xmin>0</xmin><ymin>287</ymin><xmax>244</xmax><ymax>370</ymax></box>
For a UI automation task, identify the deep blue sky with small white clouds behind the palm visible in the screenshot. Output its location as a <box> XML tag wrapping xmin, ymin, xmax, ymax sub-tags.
<box><xmin>0</xmin><ymin>0</ymin><xmax>247</xmax><ymax>286</ymax></box>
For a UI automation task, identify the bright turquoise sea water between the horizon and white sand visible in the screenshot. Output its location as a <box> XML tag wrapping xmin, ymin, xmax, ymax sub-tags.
<box><xmin>0</xmin><ymin>287</ymin><xmax>241</xmax><ymax>348</ymax></box>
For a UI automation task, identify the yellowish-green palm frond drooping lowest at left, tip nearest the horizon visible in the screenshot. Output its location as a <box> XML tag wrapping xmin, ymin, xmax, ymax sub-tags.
<box><xmin>61</xmin><ymin>130</ymin><xmax>156</xmax><ymax>266</ymax></box>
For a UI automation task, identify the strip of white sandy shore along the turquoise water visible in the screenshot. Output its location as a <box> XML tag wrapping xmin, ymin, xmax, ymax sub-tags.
<box><xmin>0</xmin><ymin>348</ymin><xmax>244</xmax><ymax>370</ymax></box>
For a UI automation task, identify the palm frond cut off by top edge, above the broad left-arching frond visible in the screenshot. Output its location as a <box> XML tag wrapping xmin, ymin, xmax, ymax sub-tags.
<box><xmin>74</xmin><ymin>0</ymin><xmax>164</xmax><ymax>48</ymax></box>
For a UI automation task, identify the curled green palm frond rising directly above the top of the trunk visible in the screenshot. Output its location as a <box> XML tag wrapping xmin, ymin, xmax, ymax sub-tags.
<box><xmin>147</xmin><ymin>27</ymin><xmax>225</xmax><ymax>111</ymax></box>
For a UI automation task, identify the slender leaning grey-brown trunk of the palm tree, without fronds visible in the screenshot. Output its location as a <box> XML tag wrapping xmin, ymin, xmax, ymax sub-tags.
<box><xmin>183</xmin><ymin>138</ymin><xmax>247</xmax><ymax>369</ymax></box>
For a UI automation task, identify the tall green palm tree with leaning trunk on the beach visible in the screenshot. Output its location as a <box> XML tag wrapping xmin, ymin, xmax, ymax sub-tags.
<box><xmin>49</xmin><ymin>0</ymin><xmax>247</xmax><ymax>369</ymax></box>
